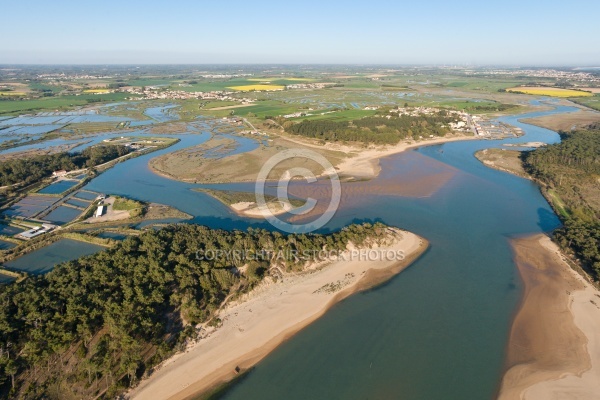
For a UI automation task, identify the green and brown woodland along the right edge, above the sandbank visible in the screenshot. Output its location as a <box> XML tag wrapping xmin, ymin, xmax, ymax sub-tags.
<box><xmin>523</xmin><ymin>130</ymin><xmax>600</xmax><ymax>277</ymax></box>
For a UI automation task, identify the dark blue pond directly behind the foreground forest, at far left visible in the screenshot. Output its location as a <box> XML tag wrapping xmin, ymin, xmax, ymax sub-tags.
<box><xmin>5</xmin><ymin>239</ymin><xmax>104</xmax><ymax>275</ymax></box>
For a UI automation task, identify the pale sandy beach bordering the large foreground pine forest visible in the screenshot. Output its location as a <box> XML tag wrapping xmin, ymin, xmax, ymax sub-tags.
<box><xmin>130</xmin><ymin>229</ymin><xmax>428</xmax><ymax>399</ymax></box>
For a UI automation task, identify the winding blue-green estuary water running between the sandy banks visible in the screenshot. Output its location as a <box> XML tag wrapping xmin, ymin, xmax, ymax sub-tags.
<box><xmin>54</xmin><ymin>101</ymin><xmax>576</xmax><ymax>400</ymax></box>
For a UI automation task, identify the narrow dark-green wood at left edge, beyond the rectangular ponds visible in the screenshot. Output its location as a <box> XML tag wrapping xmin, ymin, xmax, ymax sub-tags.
<box><xmin>0</xmin><ymin>145</ymin><xmax>129</xmax><ymax>186</ymax></box>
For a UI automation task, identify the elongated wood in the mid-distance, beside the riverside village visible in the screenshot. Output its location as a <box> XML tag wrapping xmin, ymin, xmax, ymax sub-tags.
<box><xmin>284</xmin><ymin>111</ymin><xmax>457</xmax><ymax>144</ymax></box>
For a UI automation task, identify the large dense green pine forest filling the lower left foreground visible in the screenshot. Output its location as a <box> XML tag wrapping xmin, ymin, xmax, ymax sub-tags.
<box><xmin>0</xmin><ymin>224</ymin><xmax>386</xmax><ymax>398</ymax></box>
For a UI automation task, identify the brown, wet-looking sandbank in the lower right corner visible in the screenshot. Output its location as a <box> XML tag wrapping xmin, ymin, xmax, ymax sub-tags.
<box><xmin>499</xmin><ymin>235</ymin><xmax>600</xmax><ymax>400</ymax></box>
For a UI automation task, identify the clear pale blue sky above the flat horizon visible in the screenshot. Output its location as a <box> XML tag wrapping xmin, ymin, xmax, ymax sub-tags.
<box><xmin>0</xmin><ymin>0</ymin><xmax>600</xmax><ymax>66</ymax></box>
